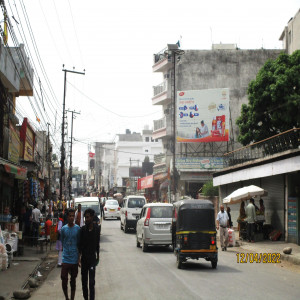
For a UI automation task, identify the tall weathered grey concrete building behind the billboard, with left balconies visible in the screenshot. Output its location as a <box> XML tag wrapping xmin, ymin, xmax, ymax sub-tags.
<box><xmin>152</xmin><ymin>44</ymin><xmax>281</xmax><ymax>196</ymax></box>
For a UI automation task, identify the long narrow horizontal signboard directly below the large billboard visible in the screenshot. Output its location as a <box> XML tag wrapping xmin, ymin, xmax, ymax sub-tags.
<box><xmin>175</xmin><ymin>157</ymin><xmax>224</xmax><ymax>170</ymax></box>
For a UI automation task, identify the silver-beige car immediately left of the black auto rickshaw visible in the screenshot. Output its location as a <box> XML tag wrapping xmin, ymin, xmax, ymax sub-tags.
<box><xmin>136</xmin><ymin>203</ymin><xmax>173</xmax><ymax>252</ymax></box>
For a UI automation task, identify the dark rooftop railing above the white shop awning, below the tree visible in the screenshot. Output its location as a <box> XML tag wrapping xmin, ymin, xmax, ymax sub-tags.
<box><xmin>224</xmin><ymin>128</ymin><xmax>300</xmax><ymax>167</ymax></box>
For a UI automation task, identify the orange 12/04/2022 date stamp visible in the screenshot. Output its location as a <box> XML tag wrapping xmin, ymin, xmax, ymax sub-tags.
<box><xmin>236</xmin><ymin>253</ymin><xmax>281</xmax><ymax>264</ymax></box>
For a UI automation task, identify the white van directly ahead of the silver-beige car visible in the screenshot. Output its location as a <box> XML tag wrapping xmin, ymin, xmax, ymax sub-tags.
<box><xmin>121</xmin><ymin>196</ymin><xmax>146</xmax><ymax>233</ymax></box>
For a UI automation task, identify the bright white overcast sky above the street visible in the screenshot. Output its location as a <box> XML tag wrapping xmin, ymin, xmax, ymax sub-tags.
<box><xmin>0</xmin><ymin>0</ymin><xmax>300</xmax><ymax>169</ymax></box>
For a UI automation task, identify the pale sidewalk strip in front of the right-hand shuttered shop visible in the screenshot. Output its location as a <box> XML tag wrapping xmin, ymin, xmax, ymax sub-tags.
<box><xmin>231</xmin><ymin>231</ymin><xmax>300</xmax><ymax>265</ymax></box>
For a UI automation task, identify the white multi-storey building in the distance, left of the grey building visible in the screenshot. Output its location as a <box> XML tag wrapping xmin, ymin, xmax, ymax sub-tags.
<box><xmin>113</xmin><ymin>128</ymin><xmax>163</xmax><ymax>187</ymax></box>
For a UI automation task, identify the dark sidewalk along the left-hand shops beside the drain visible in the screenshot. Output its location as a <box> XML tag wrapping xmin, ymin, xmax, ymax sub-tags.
<box><xmin>0</xmin><ymin>246</ymin><xmax>57</xmax><ymax>299</ymax></box>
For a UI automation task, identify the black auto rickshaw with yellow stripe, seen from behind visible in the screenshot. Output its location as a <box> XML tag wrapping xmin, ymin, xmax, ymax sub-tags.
<box><xmin>171</xmin><ymin>199</ymin><xmax>218</xmax><ymax>269</ymax></box>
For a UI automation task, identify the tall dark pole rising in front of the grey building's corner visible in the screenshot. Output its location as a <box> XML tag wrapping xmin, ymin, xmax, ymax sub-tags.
<box><xmin>165</xmin><ymin>44</ymin><xmax>185</xmax><ymax>202</ymax></box>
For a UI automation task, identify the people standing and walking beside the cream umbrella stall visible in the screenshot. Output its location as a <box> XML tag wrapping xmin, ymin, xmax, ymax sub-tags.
<box><xmin>216</xmin><ymin>198</ymin><xmax>265</xmax><ymax>251</ymax></box>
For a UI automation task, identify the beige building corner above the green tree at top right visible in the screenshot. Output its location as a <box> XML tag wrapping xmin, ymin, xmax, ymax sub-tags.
<box><xmin>279</xmin><ymin>9</ymin><xmax>300</xmax><ymax>54</ymax></box>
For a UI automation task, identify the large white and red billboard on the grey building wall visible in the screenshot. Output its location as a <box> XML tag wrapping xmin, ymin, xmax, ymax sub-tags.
<box><xmin>176</xmin><ymin>88</ymin><xmax>229</xmax><ymax>143</ymax></box>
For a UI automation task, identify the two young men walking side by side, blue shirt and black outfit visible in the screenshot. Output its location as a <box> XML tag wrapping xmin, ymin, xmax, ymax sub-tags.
<box><xmin>56</xmin><ymin>204</ymin><xmax>100</xmax><ymax>300</ymax></box>
